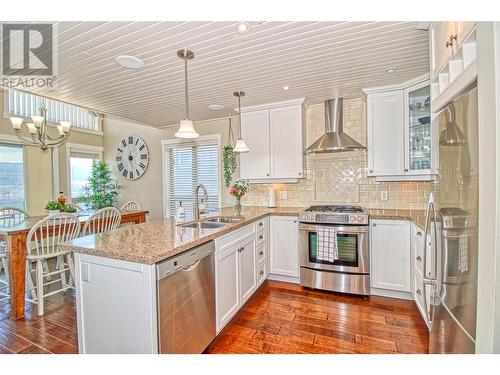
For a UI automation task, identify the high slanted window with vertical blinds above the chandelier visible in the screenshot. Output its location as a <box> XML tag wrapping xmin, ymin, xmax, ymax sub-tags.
<box><xmin>5</xmin><ymin>89</ymin><xmax>101</xmax><ymax>131</ymax></box>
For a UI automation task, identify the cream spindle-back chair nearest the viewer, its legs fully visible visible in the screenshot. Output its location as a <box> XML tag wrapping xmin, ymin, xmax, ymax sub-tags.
<box><xmin>26</xmin><ymin>213</ymin><xmax>80</xmax><ymax>316</ymax></box>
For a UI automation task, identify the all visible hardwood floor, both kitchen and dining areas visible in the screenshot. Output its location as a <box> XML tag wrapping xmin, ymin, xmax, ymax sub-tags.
<box><xmin>0</xmin><ymin>281</ymin><xmax>428</xmax><ymax>354</ymax></box>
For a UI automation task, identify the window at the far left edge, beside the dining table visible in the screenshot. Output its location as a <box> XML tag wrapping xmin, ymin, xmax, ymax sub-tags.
<box><xmin>0</xmin><ymin>144</ymin><xmax>26</xmax><ymax>209</ymax></box>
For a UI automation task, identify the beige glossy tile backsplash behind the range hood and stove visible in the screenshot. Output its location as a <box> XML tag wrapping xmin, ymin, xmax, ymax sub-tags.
<box><xmin>242</xmin><ymin>99</ymin><xmax>433</xmax><ymax>210</ymax></box>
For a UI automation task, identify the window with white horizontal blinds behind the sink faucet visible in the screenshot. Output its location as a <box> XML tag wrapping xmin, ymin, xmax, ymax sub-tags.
<box><xmin>163</xmin><ymin>136</ymin><xmax>220</xmax><ymax>217</ymax></box>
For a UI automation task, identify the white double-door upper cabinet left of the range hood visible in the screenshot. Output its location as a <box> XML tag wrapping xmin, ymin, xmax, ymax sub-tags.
<box><xmin>240</xmin><ymin>99</ymin><xmax>305</xmax><ymax>182</ymax></box>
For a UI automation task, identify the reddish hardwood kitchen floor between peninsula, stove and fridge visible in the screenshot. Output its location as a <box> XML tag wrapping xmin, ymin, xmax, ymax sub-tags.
<box><xmin>205</xmin><ymin>281</ymin><xmax>428</xmax><ymax>354</ymax></box>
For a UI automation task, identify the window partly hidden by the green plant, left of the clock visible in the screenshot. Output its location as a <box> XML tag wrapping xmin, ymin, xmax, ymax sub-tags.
<box><xmin>69</xmin><ymin>146</ymin><xmax>101</xmax><ymax>202</ymax></box>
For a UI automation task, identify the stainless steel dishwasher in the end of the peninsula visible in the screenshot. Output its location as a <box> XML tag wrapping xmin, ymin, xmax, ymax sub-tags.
<box><xmin>156</xmin><ymin>241</ymin><xmax>216</xmax><ymax>354</ymax></box>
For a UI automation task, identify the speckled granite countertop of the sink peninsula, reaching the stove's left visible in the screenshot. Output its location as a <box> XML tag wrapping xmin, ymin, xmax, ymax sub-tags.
<box><xmin>59</xmin><ymin>207</ymin><xmax>304</xmax><ymax>264</ymax></box>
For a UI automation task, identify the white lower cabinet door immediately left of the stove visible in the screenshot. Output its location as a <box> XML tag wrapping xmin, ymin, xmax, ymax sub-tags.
<box><xmin>270</xmin><ymin>216</ymin><xmax>299</xmax><ymax>277</ymax></box>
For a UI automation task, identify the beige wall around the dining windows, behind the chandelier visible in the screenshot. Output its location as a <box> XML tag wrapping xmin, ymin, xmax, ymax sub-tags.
<box><xmin>0</xmin><ymin>90</ymin><xmax>103</xmax><ymax>215</ymax></box>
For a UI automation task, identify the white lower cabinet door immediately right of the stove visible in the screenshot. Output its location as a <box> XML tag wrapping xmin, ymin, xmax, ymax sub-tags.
<box><xmin>370</xmin><ymin>220</ymin><xmax>411</xmax><ymax>294</ymax></box>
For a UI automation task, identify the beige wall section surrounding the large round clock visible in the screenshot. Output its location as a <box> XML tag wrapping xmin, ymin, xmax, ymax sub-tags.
<box><xmin>103</xmin><ymin>116</ymin><xmax>163</xmax><ymax>218</ymax></box>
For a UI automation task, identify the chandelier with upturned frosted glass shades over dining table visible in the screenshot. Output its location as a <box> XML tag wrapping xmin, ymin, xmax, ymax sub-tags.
<box><xmin>10</xmin><ymin>103</ymin><xmax>71</xmax><ymax>151</ymax></box>
